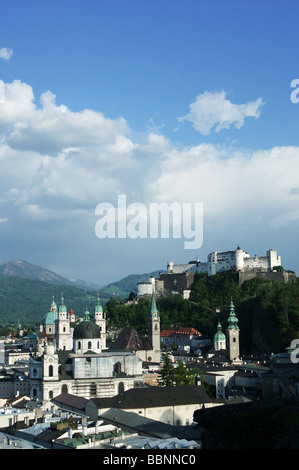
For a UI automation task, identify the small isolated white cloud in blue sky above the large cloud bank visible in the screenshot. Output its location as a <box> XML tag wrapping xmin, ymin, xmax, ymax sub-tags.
<box><xmin>178</xmin><ymin>91</ymin><xmax>263</xmax><ymax>135</ymax></box>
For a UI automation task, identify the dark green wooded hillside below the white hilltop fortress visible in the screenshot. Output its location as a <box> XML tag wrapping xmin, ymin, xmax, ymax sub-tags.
<box><xmin>106</xmin><ymin>271</ymin><xmax>299</xmax><ymax>354</ymax></box>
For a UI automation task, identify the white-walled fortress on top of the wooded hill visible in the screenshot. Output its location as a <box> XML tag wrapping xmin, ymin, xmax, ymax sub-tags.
<box><xmin>137</xmin><ymin>246</ymin><xmax>296</xmax><ymax>298</ymax></box>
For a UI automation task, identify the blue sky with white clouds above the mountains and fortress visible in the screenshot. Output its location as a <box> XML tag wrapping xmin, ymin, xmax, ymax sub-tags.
<box><xmin>0</xmin><ymin>0</ymin><xmax>299</xmax><ymax>284</ymax></box>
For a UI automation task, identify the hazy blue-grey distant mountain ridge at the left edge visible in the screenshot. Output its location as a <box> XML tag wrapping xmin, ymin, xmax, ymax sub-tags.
<box><xmin>0</xmin><ymin>260</ymin><xmax>103</xmax><ymax>289</ymax></box>
